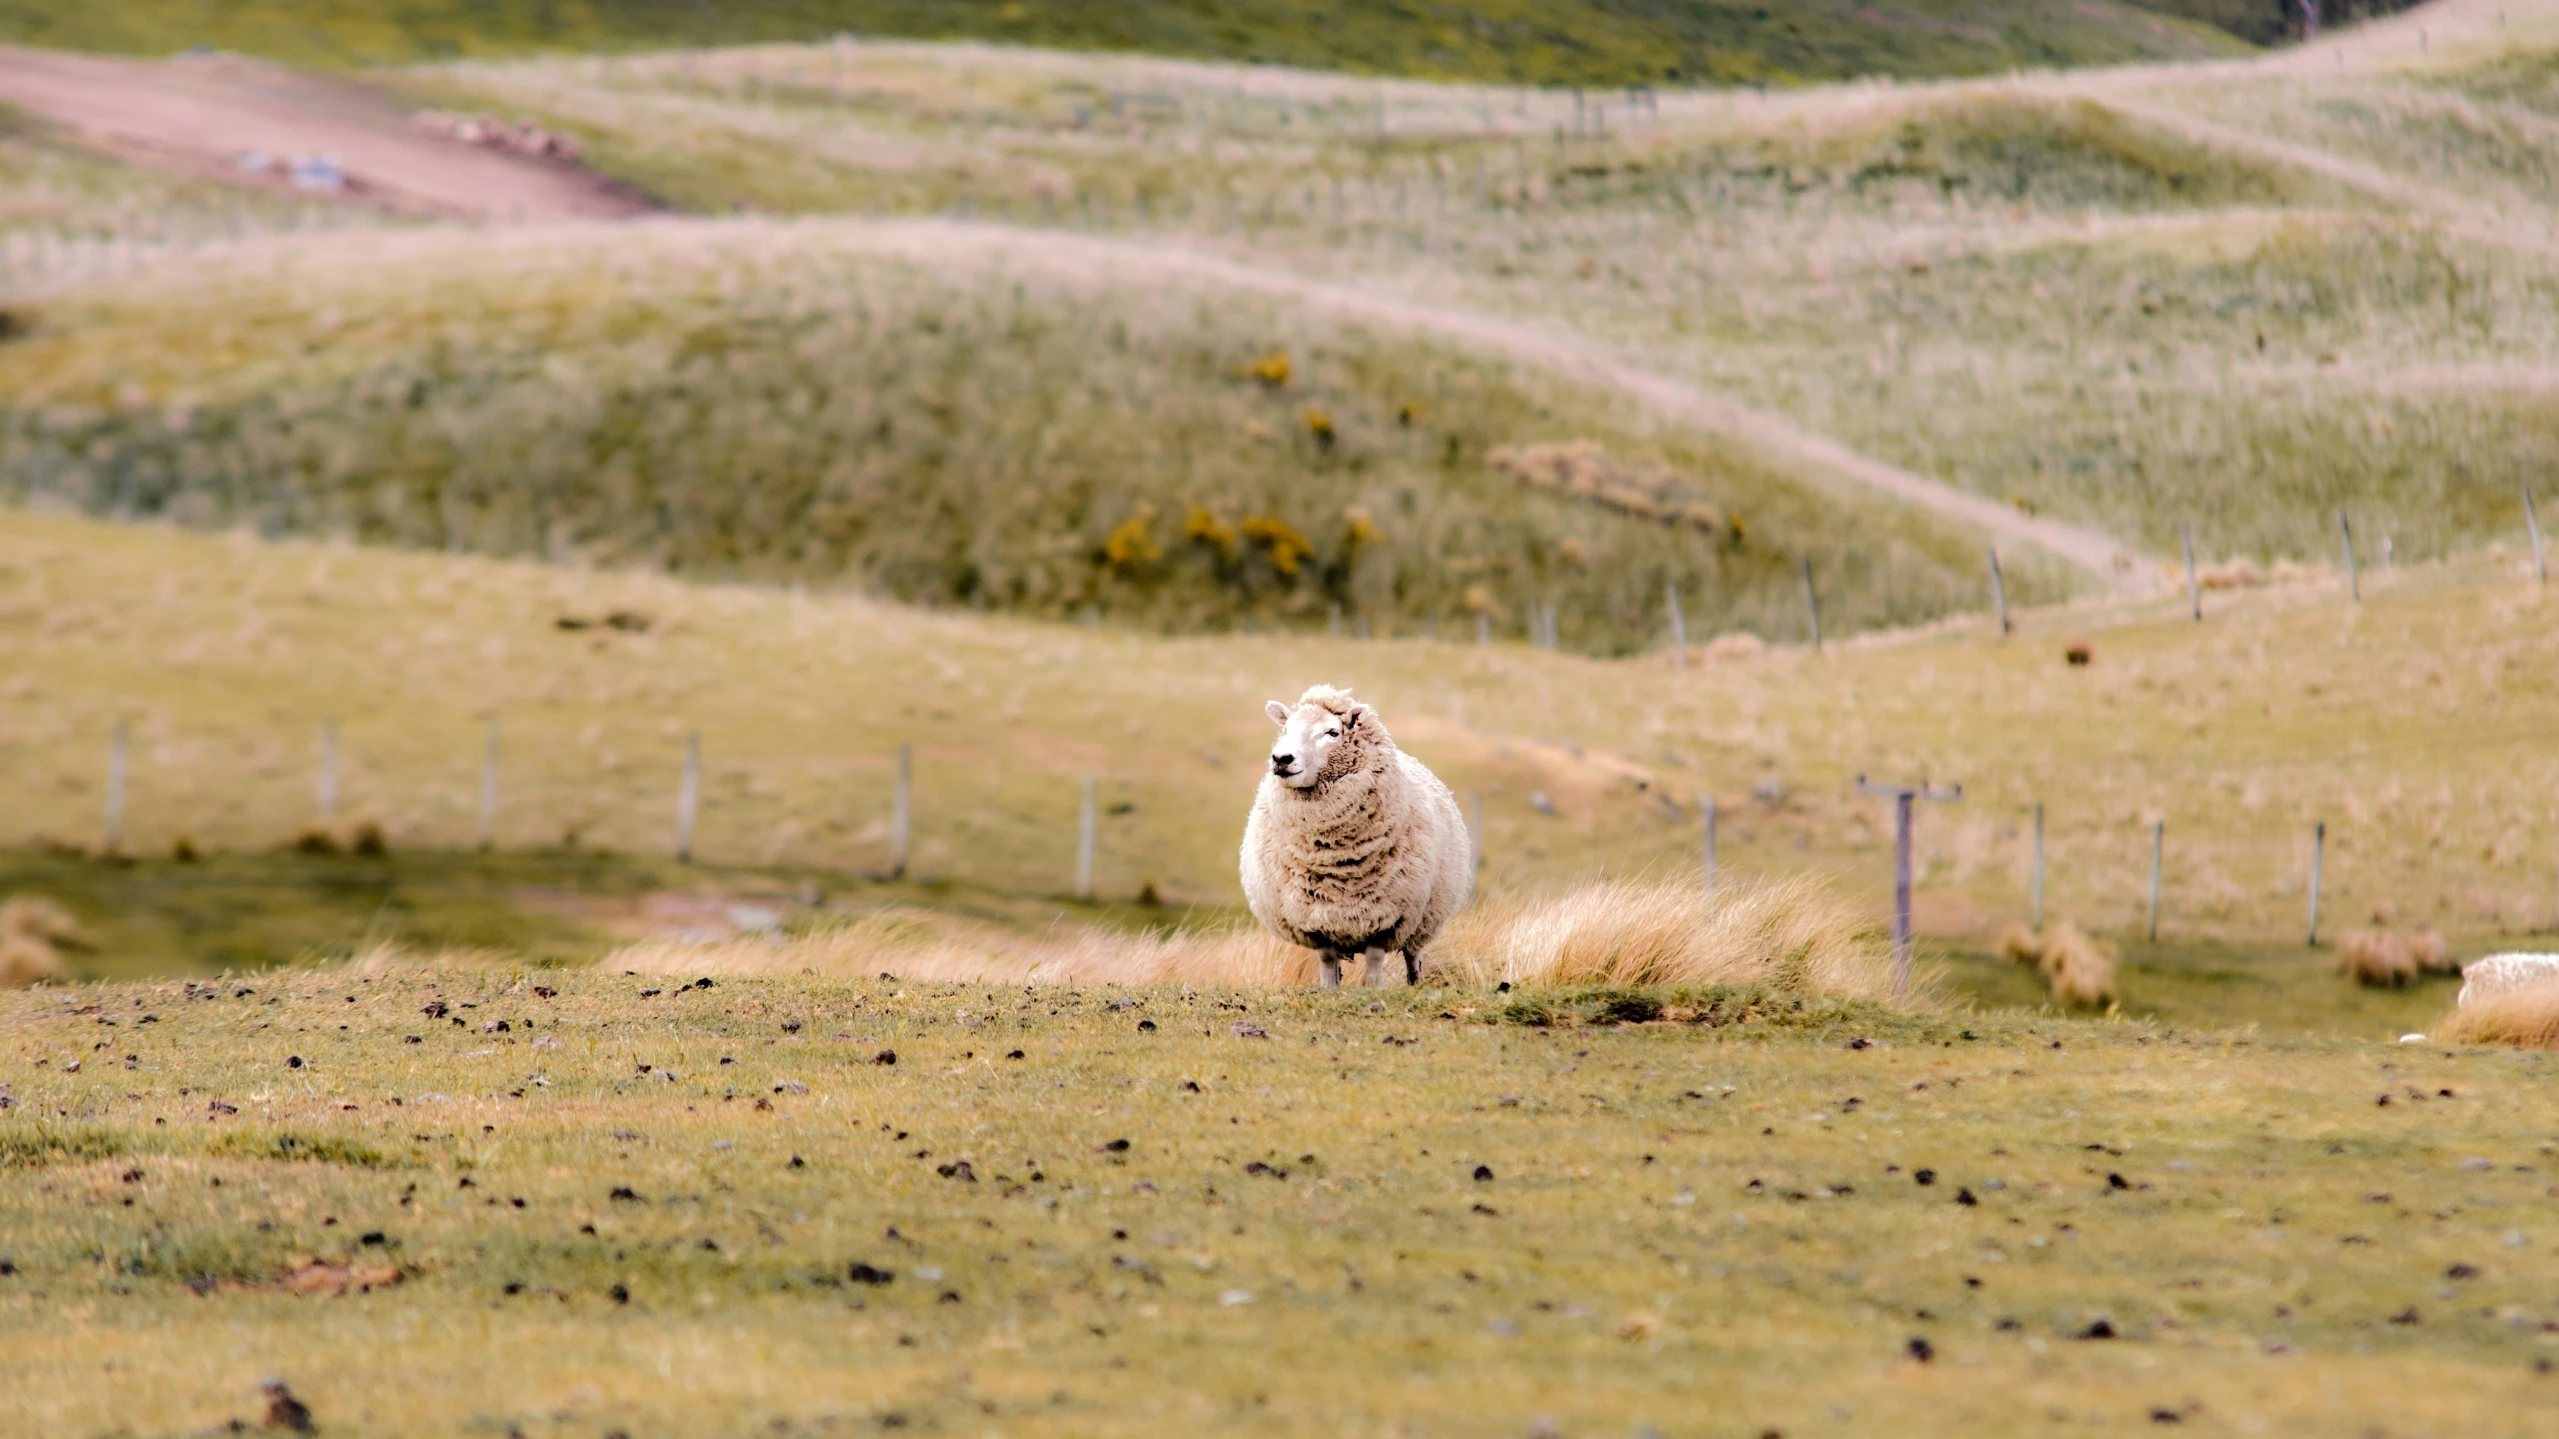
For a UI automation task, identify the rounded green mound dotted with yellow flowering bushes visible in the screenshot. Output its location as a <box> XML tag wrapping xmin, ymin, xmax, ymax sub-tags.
<box><xmin>0</xmin><ymin>225</ymin><xmax>2052</xmax><ymax>653</ymax></box>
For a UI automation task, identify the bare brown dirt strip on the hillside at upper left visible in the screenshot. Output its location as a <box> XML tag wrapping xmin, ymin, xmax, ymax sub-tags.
<box><xmin>0</xmin><ymin>46</ymin><xmax>653</xmax><ymax>220</ymax></box>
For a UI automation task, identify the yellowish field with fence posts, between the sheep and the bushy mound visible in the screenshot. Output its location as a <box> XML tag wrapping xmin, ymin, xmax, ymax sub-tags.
<box><xmin>0</xmin><ymin>515</ymin><xmax>2559</xmax><ymax>968</ymax></box>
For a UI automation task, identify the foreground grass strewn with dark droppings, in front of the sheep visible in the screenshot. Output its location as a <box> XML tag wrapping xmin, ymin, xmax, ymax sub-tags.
<box><xmin>0</xmin><ymin>968</ymin><xmax>2559</xmax><ymax>1436</ymax></box>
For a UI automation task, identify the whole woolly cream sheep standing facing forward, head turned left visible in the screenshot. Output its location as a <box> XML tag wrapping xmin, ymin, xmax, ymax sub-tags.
<box><xmin>1244</xmin><ymin>684</ymin><xmax>1474</xmax><ymax>972</ymax></box>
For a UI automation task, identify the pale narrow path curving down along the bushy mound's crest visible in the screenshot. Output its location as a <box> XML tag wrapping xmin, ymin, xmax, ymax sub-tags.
<box><xmin>865</xmin><ymin>220</ymin><xmax>2155</xmax><ymax>589</ymax></box>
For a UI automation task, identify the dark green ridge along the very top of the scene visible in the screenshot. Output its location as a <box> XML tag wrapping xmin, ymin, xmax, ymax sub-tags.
<box><xmin>0</xmin><ymin>0</ymin><xmax>2244</xmax><ymax>84</ymax></box>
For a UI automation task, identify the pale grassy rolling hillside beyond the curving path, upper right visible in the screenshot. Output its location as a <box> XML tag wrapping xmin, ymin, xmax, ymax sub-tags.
<box><xmin>360</xmin><ymin>3</ymin><xmax>2559</xmax><ymax>570</ymax></box>
